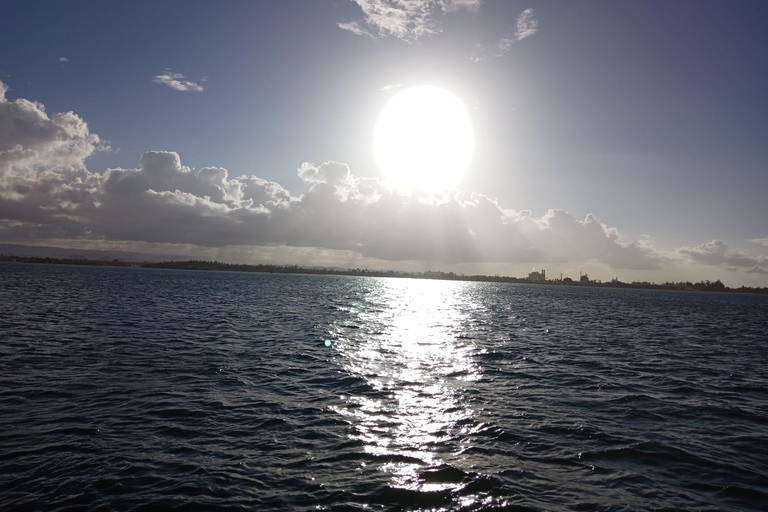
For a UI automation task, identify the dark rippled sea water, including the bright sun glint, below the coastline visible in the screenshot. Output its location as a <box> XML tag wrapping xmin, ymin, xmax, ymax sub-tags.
<box><xmin>0</xmin><ymin>264</ymin><xmax>768</xmax><ymax>510</ymax></box>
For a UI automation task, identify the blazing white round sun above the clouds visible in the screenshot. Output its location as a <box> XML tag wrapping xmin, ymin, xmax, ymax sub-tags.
<box><xmin>373</xmin><ymin>85</ymin><xmax>475</xmax><ymax>192</ymax></box>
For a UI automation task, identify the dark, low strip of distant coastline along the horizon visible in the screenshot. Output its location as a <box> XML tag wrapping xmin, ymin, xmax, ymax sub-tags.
<box><xmin>0</xmin><ymin>254</ymin><xmax>768</xmax><ymax>294</ymax></box>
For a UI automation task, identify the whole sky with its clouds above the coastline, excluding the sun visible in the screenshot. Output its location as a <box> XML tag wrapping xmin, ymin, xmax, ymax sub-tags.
<box><xmin>0</xmin><ymin>0</ymin><xmax>768</xmax><ymax>286</ymax></box>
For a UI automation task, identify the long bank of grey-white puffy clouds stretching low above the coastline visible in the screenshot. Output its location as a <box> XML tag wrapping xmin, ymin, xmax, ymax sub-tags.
<box><xmin>0</xmin><ymin>82</ymin><xmax>768</xmax><ymax>280</ymax></box>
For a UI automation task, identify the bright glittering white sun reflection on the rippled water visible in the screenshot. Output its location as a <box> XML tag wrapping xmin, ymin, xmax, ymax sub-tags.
<box><xmin>334</xmin><ymin>279</ymin><xmax>480</xmax><ymax>492</ymax></box>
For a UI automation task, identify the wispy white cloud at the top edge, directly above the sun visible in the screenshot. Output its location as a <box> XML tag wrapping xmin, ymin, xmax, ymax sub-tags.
<box><xmin>338</xmin><ymin>0</ymin><xmax>481</xmax><ymax>42</ymax></box>
